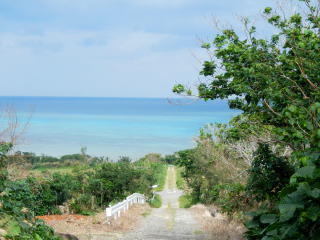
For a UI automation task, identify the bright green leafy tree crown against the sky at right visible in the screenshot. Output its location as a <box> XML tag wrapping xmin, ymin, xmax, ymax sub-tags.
<box><xmin>173</xmin><ymin>1</ymin><xmax>320</xmax><ymax>150</ymax></box>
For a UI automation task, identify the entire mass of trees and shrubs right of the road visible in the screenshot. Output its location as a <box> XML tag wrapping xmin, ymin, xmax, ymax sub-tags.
<box><xmin>173</xmin><ymin>0</ymin><xmax>320</xmax><ymax>237</ymax></box>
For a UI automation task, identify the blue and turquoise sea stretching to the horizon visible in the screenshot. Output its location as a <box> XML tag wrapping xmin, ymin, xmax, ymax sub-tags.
<box><xmin>0</xmin><ymin>97</ymin><xmax>237</xmax><ymax>159</ymax></box>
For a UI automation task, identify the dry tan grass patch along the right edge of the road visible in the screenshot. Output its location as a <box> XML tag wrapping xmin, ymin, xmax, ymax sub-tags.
<box><xmin>191</xmin><ymin>204</ymin><xmax>245</xmax><ymax>240</ymax></box>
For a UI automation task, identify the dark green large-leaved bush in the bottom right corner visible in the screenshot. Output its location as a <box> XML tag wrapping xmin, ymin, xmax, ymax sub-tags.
<box><xmin>246</xmin><ymin>150</ymin><xmax>320</xmax><ymax>240</ymax></box>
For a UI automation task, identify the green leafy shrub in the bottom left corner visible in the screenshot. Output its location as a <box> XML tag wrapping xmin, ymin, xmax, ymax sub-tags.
<box><xmin>0</xmin><ymin>143</ymin><xmax>60</xmax><ymax>240</ymax></box>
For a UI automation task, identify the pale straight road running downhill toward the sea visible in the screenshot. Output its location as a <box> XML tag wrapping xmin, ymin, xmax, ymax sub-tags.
<box><xmin>121</xmin><ymin>166</ymin><xmax>208</xmax><ymax>240</ymax></box>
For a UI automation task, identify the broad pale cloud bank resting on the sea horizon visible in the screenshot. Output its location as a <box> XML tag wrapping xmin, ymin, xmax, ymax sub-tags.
<box><xmin>0</xmin><ymin>31</ymin><xmax>202</xmax><ymax>97</ymax></box>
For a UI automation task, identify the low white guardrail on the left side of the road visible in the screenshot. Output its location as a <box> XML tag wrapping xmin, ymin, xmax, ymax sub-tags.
<box><xmin>106</xmin><ymin>193</ymin><xmax>146</xmax><ymax>219</ymax></box>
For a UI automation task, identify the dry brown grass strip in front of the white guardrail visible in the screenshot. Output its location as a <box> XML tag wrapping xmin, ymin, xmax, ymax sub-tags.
<box><xmin>42</xmin><ymin>204</ymin><xmax>150</xmax><ymax>239</ymax></box>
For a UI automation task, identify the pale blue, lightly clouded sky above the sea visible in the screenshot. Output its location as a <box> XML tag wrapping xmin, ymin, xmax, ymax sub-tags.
<box><xmin>0</xmin><ymin>0</ymin><xmax>280</xmax><ymax>97</ymax></box>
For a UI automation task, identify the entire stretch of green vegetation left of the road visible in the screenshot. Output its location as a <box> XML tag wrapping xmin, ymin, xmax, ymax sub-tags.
<box><xmin>0</xmin><ymin>143</ymin><xmax>166</xmax><ymax>240</ymax></box>
